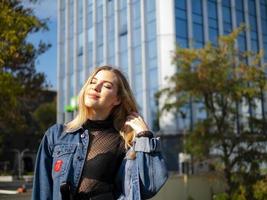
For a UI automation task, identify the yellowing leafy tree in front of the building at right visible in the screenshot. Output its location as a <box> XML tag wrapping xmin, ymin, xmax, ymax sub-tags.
<box><xmin>158</xmin><ymin>27</ymin><xmax>267</xmax><ymax>200</ymax></box>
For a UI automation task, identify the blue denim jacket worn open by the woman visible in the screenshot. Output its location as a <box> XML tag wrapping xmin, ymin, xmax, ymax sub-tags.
<box><xmin>32</xmin><ymin>124</ymin><xmax>168</xmax><ymax>200</ymax></box>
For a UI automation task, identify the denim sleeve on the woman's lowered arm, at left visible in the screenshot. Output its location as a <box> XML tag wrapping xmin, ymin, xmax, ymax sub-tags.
<box><xmin>32</xmin><ymin>128</ymin><xmax>53</xmax><ymax>200</ymax></box>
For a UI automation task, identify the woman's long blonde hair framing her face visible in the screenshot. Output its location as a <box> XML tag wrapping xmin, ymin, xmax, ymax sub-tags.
<box><xmin>66</xmin><ymin>65</ymin><xmax>138</xmax><ymax>147</ymax></box>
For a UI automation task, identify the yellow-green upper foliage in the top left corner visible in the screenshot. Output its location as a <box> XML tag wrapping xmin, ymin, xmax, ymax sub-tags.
<box><xmin>0</xmin><ymin>0</ymin><xmax>47</xmax><ymax>69</ymax></box>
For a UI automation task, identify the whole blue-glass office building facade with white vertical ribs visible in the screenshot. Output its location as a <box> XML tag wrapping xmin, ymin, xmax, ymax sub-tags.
<box><xmin>57</xmin><ymin>0</ymin><xmax>267</xmax><ymax>168</ymax></box>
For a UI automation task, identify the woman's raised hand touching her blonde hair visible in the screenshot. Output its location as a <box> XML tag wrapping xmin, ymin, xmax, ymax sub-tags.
<box><xmin>125</xmin><ymin>112</ymin><xmax>149</xmax><ymax>135</ymax></box>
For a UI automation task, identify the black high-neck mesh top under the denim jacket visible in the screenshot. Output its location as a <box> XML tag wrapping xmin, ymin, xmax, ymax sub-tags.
<box><xmin>75</xmin><ymin>115</ymin><xmax>126</xmax><ymax>199</ymax></box>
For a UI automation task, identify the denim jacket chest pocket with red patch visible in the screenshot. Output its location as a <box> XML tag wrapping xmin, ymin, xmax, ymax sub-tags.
<box><xmin>52</xmin><ymin>144</ymin><xmax>77</xmax><ymax>178</ymax></box>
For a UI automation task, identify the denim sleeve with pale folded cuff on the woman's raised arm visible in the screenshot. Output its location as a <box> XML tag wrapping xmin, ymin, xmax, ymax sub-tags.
<box><xmin>134</xmin><ymin>137</ymin><xmax>168</xmax><ymax>199</ymax></box>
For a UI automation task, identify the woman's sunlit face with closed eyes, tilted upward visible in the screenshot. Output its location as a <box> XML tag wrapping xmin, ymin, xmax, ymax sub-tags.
<box><xmin>84</xmin><ymin>70</ymin><xmax>120</xmax><ymax>113</ymax></box>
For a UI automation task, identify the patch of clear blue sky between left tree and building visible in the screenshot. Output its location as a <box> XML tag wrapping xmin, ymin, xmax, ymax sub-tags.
<box><xmin>24</xmin><ymin>0</ymin><xmax>57</xmax><ymax>90</ymax></box>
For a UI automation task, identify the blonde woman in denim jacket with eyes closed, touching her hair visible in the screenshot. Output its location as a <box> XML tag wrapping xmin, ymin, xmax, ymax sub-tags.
<box><xmin>32</xmin><ymin>66</ymin><xmax>167</xmax><ymax>200</ymax></box>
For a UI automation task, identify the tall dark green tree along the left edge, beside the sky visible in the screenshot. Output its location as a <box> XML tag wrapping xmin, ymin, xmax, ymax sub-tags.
<box><xmin>0</xmin><ymin>0</ymin><xmax>50</xmax><ymax>153</ymax></box>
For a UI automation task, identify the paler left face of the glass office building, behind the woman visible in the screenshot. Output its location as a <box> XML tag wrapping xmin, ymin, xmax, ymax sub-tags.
<box><xmin>57</xmin><ymin>0</ymin><xmax>163</xmax><ymax>130</ymax></box>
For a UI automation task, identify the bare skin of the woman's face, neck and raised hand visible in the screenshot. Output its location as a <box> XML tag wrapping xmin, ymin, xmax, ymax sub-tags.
<box><xmin>84</xmin><ymin>70</ymin><xmax>149</xmax><ymax>134</ymax></box>
